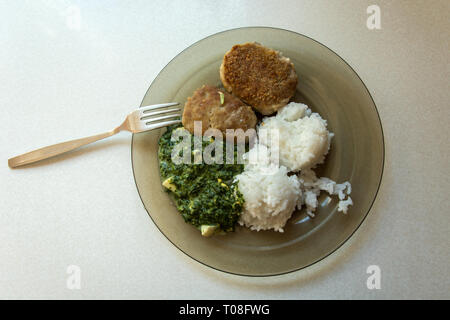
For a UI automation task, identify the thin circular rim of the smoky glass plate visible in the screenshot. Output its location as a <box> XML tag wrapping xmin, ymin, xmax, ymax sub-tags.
<box><xmin>130</xmin><ymin>26</ymin><xmax>386</xmax><ymax>278</ymax></box>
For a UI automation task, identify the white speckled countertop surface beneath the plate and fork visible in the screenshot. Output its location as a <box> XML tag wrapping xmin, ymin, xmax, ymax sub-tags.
<box><xmin>0</xmin><ymin>0</ymin><xmax>450</xmax><ymax>299</ymax></box>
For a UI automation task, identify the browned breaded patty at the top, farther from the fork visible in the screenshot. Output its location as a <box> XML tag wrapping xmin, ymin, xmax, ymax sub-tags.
<box><xmin>220</xmin><ymin>42</ymin><xmax>298</xmax><ymax>115</ymax></box>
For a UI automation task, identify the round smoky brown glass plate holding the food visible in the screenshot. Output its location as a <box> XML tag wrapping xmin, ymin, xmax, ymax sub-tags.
<box><xmin>131</xmin><ymin>27</ymin><xmax>384</xmax><ymax>276</ymax></box>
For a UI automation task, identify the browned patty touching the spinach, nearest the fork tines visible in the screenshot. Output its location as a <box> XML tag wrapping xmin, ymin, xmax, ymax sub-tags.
<box><xmin>182</xmin><ymin>85</ymin><xmax>256</xmax><ymax>136</ymax></box>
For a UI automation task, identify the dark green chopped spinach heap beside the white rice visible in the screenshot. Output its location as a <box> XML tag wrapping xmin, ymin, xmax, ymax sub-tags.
<box><xmin>158</xmin><ymin>125</ymin><xmax>244</xmax><ymax>236</ymax></box>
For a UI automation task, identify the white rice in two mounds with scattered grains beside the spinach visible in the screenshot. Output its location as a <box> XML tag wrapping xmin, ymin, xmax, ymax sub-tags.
<box><xmin>236</xmin><ymin>102</ymin><xmax>353</xmax><ymax>232</ymax></box>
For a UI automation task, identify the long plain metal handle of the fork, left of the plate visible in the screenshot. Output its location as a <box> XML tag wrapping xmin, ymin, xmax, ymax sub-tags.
<box><xmin>8</xmin><ymin>127</ymin><xmax>121</xmax><ymax>168</ymax></box>
